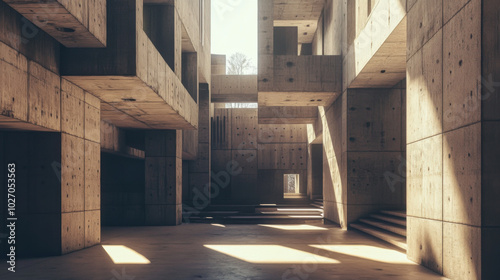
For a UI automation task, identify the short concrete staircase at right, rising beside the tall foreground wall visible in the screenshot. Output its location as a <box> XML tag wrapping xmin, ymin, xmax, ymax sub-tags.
<box><xmin>350</xmin><ymin>211</ymin><xmax>407</xmax><ymax>251</ymax></box>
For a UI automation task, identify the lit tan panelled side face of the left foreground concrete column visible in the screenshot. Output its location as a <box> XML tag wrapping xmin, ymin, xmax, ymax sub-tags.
<box><xmin>61</xmin><ymin>83</ymin><xmax>101</xmax><ymax>253</ymax></box>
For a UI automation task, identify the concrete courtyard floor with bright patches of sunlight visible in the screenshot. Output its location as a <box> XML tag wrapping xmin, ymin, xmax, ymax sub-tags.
<box><xmin>0</xmin><ymin>222</ymin><xmax>445</xmax><ymax>280</ymax></box>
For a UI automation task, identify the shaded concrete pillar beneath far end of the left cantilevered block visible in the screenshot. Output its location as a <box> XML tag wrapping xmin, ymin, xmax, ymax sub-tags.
<box><xmin>145</xmin><ymin>130</ymin><xmax>182</xmax><ymax>226</ymax></box>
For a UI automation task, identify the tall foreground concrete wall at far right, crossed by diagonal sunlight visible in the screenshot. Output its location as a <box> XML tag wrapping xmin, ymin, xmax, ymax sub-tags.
<box><xmin>407</xmin><ymin>0</ymin><xmax>500</xmax><ymax>279</ymax></box>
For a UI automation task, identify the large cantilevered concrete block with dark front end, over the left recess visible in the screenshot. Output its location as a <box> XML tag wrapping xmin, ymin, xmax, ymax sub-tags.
<box><xmin>61</xmin><ymin>0</ymin><xmax>198</xmax><ymax>130</ymax></box>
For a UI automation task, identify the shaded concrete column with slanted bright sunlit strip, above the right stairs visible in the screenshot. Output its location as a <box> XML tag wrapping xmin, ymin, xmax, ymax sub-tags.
<box><xmin>320</xmin><ymin>85</ymin><xmax>406</xmax><ymax>228</ymax></box>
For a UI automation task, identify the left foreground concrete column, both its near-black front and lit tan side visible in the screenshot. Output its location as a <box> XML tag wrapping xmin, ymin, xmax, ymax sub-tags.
<box><xmin>0</xmin><ymin>79</ymin><xmax>101</xmax><ymax>257</ymax></box>
